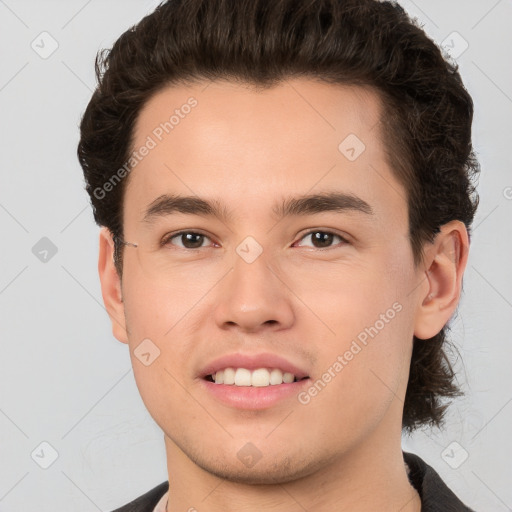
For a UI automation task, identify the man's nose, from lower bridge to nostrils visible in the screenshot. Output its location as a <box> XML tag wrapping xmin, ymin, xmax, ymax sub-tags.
<box><xmin>214</xmin><ymin>247</ymin><xmax>295</xmax><ymax>332</ymax></box>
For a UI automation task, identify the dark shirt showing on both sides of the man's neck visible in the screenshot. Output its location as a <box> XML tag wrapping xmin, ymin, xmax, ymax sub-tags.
<box><xmin>113</xmin><ymin>452</ymin><xmax>474</xmax><ymax>512</ymax></box>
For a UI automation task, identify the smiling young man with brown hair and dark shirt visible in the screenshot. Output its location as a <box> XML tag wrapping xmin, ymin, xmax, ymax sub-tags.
<box><xmin>78</xmin><ymin>0</ymin><xmax>479</xmax><ymax>512</ymax></box>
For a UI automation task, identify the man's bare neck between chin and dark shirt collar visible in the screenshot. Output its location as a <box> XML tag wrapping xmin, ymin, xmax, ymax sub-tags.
<box><xmin>165</xmin><ymin>432</ymin><xmax>421</xmax><ymax>512</ymax></box>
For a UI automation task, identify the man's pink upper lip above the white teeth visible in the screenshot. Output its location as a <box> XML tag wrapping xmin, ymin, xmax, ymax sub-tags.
<box><xmin>199</xmin><ymin>353</ymin><xmax>308</xmax><ymax>380</ymax></box>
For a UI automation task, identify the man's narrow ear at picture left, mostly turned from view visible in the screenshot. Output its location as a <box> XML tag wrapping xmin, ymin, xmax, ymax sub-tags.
<box><xmin>98</xmin><ymin>227</ymin><xmax>128</xmax><ymax>343</ymax></box>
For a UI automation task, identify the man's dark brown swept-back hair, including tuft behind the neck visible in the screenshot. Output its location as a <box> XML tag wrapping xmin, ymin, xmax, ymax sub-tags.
<box><xmin>78</xmin><ymin>0</ymin><xmax>480</xmax><ymax>431</ymax></box>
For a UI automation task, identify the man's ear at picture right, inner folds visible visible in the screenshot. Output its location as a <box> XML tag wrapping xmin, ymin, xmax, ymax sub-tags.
<box><xmin>414</xmin><ymin>220</ymin><xmax>469</xmax><ymax>340</ymax></box>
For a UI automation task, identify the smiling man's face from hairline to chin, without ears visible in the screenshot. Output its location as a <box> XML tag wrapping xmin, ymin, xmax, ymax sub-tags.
<box><xmin>113</xmin><ymin>79</ymin><xmax>428</xmax><ymax>483</ymax></box>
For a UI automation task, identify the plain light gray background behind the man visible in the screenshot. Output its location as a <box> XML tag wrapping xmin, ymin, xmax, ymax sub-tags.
<box><xmin>0</xmin><ymin>0</ymin><xmax>512</xmax><ymax>512</ymax></box>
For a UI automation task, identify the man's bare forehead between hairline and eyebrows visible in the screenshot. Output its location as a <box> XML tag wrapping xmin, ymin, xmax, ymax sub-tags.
<box><xmin>125</xmin><ymin>79</ymin><xmax>406</xmax><ymax>231</ymax></box>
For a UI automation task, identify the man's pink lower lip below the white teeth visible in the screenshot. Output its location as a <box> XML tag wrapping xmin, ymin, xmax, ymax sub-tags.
<box><xmin>201</xmin><ymin>379</ymin><xmax>310</xmax><ymax>410</ymax></box>
